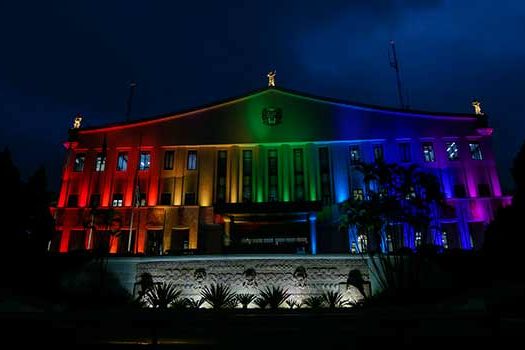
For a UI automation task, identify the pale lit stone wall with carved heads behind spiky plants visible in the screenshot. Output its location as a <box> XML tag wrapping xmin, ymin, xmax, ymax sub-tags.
<box><xmin>110</xmin><ymin>255</ymin><xmax>370</xmax><ymax>302</ymax></box>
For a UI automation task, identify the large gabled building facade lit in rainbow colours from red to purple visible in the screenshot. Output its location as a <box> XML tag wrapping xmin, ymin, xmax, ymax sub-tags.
<box><xmin>50</xmin><ymin>86</ymin><xmax>510</xmax><ymax>256</ymax></box>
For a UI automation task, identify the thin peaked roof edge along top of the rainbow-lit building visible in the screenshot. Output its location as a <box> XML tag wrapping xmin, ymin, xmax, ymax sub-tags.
<box><xmin>78</xmin><ymin>87</ymin><xmax>479</xmax><ymax>134</ymax></box>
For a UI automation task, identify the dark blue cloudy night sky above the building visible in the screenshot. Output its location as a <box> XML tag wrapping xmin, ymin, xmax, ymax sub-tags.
<box><xmin>0</xmin><ymin>0</ymin><xmax>525</xmax><ymax>193</ymax></box>
